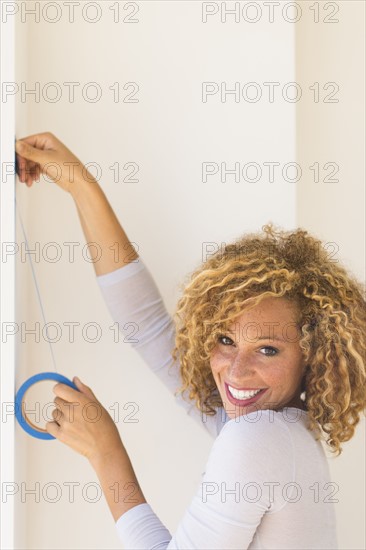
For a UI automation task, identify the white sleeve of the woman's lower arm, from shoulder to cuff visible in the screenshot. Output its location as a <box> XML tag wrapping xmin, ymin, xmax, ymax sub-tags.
<box><xmin>116</xmin><ymin>411</ymin><xmax>294</xmax><ymax>550</ymax></box>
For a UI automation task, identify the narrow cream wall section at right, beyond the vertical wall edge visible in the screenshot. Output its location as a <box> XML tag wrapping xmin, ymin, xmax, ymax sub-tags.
<box><xmin>296</xmin><ymin>1</ymin><xmax>366</xmax><ymax>549</ymax></box>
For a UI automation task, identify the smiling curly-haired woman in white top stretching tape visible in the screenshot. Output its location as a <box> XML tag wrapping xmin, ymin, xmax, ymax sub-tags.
<box><xmin>16</xmin><ymin>133</ymin><xmax>366</xmax><ymax>550</ymax></box>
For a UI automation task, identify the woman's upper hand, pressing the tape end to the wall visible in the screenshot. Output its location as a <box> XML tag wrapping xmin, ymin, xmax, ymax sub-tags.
<box><xmin>15</xmin><ymin>132</ymin><xmax>95</xmax><ymax>194</ymax></box>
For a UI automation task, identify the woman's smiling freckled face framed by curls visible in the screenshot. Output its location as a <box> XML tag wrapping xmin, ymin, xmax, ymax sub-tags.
<box><xmin>210</xmin><ymin>297</ymin><xmax>305</xmax><ymax>419</ymax></box>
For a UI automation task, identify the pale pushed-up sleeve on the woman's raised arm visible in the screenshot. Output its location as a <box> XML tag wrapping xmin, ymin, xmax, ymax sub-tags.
<box><xmin>96</xmin><ymin>256</ymin><xmax>226</xmax><ymax>437</ymax></box>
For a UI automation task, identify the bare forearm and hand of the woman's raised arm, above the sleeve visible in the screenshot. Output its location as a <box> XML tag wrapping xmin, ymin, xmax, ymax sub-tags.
<box><xmin>16</xmin><ymin>132</ymin><xmax>138</xmax><ymax>275</ymax></box>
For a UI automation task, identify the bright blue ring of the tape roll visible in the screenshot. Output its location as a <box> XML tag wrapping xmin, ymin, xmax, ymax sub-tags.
<box><xmin>15</xmin><ymin>372</ymin><xmax>79</xmax><ymax>439</ymax></box>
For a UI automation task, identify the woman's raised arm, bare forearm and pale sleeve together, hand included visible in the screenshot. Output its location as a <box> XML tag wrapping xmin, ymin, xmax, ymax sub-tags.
<box><xmin>17</xmin><ymin>133</ymin><xmax>225</xmax><ymax>437</ymax></box>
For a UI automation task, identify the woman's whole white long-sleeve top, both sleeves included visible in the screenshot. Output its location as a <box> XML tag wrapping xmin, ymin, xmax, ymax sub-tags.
<box><xmin>96</xmin><ymin>256</ymin><xmax>339</xmax><ymax>550</ymax></box>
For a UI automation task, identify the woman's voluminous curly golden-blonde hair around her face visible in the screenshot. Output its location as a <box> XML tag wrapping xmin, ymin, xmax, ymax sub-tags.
<box><xmin>172</xmin><ymin>223</ymin><xmax>366</xmax><ymax>456</ymax></box>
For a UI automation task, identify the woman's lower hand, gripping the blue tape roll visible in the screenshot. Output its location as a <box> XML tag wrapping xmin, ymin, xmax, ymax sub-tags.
<box><xmin>46</xmin><ymin>377</ymin><xmax>123</xmax><ymax>460</ymax></box>
